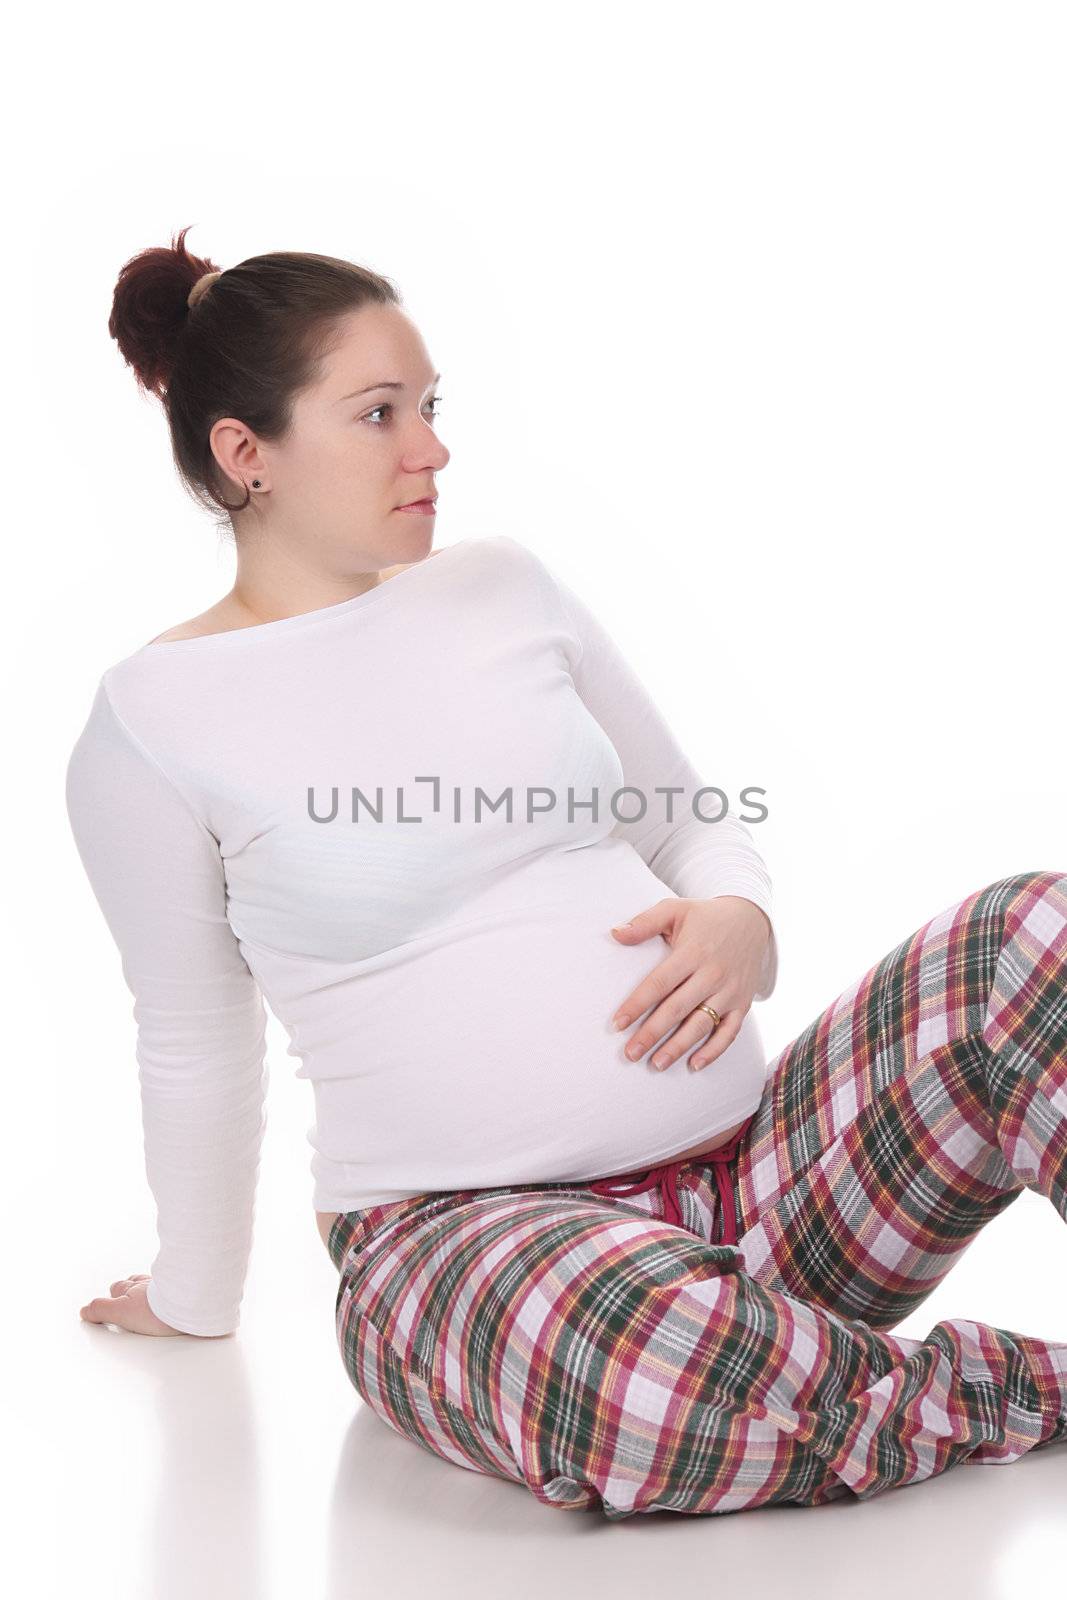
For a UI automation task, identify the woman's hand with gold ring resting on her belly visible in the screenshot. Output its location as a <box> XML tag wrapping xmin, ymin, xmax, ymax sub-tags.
<box><xmin>611</xmin><ymin>894</ymin><xmax>771</xmax><ymax>1072</ymax></box>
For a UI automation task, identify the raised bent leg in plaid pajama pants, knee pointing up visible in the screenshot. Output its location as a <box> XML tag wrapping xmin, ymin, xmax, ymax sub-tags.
<box><xmin>735</xmin><ymin>872</ymin><xmax>1067</xmax><ymax>1330</ymax></box>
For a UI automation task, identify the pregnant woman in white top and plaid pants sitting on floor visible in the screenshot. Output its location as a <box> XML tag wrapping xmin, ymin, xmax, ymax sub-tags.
<box><xmin>67</xmin><ymin>230</ymin><xmax>1067</xmax><ymax>1518</ymax></box>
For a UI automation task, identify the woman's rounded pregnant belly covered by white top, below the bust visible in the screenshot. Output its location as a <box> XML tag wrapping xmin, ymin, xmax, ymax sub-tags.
<box><xmin>303</xmin><ymin>840</ymin><xmax>766</xmax><ymax>1238</ymax></box>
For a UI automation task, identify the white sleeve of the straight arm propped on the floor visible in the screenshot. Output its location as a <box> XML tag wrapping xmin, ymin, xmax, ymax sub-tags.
<box><xmin>66</xmin><ymin>680</ymin><xmax>267</xmax><ymax>1336</ymax></box>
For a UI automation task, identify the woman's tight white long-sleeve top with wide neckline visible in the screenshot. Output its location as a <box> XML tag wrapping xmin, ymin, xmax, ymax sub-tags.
<box><xmin>66</xmin><ymin>536</ymin><xmax>777</xmax><ymax>1334</ymax></box>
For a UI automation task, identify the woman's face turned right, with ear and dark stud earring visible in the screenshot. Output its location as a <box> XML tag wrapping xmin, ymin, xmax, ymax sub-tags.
<box><xmin>213</xmin><ymin>306</ymin><xmax>450</xmax><ymax>576</ymax></box>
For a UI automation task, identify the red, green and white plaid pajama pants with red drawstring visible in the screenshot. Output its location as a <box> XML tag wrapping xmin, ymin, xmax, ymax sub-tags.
<box><xmin>328</xmin><ymin>872</ymin><xmax>1067</xmax><ymax>1518</ymax></box>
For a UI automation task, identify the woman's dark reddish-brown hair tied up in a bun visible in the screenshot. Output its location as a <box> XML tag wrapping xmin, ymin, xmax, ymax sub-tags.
<box><xmin>107</xmin><ymin>227</ymin><xmax>402</xmax><ymax>530</ymax></box>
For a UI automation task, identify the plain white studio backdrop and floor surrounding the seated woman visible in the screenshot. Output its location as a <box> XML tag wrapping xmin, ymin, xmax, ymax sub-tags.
<box><xmin>3</xmin><ymin>0</ymin><xmax>1067</xmax><ymax>1600</ymax></box>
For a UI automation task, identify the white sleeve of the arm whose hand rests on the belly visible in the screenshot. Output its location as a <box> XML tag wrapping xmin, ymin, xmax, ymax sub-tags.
<box><xmin>531</xmin><ymin>550</ymin><xmax>777</xmax><ymax>1000</ymax></box>
